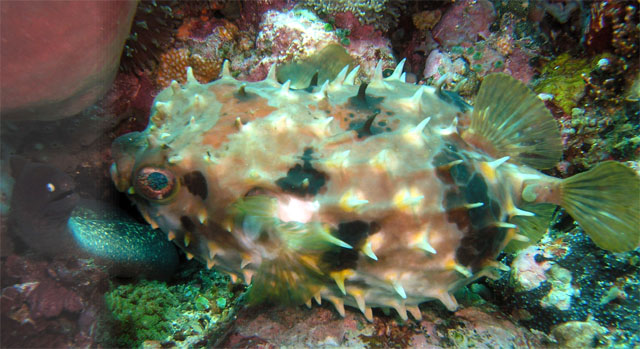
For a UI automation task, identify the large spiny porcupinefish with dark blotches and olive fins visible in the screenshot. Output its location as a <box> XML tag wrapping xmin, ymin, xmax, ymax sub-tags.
<box><xmin>111</xmin><ymin>56</ymin><xmax>640</xmax><ymax>320</ymax></box>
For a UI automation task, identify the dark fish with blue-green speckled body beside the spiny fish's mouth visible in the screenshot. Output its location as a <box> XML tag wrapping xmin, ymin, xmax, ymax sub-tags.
<box><xmin>9</xmin><ymin>157</ymin><xmax>179</xmax><ymax>279</ymax></box>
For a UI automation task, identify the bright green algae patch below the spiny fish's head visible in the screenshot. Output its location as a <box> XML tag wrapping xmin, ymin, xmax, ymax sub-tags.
<box><xmin>100</xmin><ymin>265</ymin><xmax>236</xmax><ymax>348</ymax></box>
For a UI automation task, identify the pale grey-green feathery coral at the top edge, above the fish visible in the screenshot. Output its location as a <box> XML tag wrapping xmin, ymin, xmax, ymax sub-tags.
<box><xmin>301</xmin><ymin>0</ymin><xmax>405</xmax><ymax>32</ymax></box>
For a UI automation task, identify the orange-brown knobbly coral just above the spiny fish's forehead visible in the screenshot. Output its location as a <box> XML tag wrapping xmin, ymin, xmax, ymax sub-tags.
<box><xmin>155</xmin><ymin>48</ymin><xmax>222</xmax><ymax>88</ymax></box>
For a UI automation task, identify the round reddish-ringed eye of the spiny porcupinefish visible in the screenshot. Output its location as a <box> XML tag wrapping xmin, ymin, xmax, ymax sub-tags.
<box><xmin>133</xmin><ymin>167</ymin><xmax>178</xmax><ymax>201</ymax></box>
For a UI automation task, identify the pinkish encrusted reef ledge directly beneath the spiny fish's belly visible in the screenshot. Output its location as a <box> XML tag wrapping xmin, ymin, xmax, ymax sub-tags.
<box><xmin>216</xmin><ymin>300</ymin><xmax>553</xmax><ymax>348</ymax></box>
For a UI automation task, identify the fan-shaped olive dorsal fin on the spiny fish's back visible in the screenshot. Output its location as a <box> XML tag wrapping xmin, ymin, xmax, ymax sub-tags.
<box><xmin>462</xmin><ymin>73</ymin><xmax>562</xmax><ymax>169</ymax></box>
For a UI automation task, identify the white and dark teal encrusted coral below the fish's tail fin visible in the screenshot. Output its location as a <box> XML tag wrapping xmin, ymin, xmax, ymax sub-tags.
<box><xmin>484</xmin><ymin>211</ymin><xmax>640</xmax><ymax>347</ymax></box>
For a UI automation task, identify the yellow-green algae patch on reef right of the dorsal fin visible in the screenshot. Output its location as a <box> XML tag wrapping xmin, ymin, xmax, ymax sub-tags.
<box><xmin>533</xmin><ymin>53</ymin><xmax>609</xmax><ymax>115</ymax></box>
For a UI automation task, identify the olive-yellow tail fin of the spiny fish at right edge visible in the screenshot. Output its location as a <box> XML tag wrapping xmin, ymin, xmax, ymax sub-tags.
<box><xmin>560</xmin><ymin>161</ymin><xmax>640</xmax><ymax>252</ymax></box>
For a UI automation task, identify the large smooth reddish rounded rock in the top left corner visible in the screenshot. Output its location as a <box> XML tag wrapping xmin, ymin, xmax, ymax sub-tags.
<box><xmin>0</xmin><ymin>0</ymin><xmax>137</xmax><ymax>120</ymax></box>
